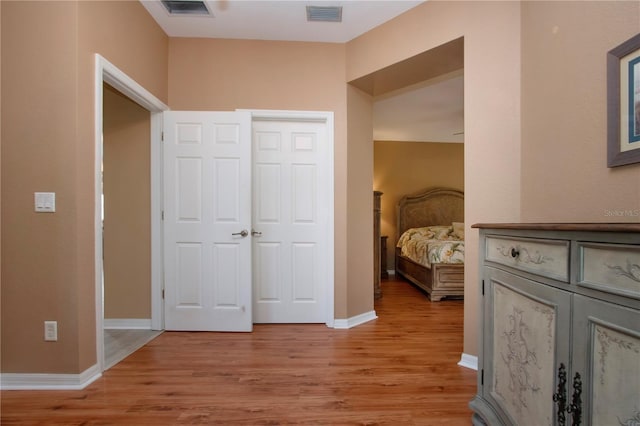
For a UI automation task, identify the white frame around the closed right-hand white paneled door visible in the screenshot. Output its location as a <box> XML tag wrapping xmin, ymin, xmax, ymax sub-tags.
<box><xmin>245</xmin><ymin>109</ymin><xmax>335</xmax><ymax>328</ymax></box>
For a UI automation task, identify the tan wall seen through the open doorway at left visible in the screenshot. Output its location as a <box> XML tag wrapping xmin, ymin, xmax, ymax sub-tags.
<box><xmin>102</xmin><ymin>84</ymin><xmax>151</xmax><ymax>319</ymax></box>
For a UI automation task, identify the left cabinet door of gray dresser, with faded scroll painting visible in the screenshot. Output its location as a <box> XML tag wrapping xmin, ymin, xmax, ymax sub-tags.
<box><xmin>482</xmin><ymin>267</ymin><xmax>571</xmax><ymax>426</ymax></box>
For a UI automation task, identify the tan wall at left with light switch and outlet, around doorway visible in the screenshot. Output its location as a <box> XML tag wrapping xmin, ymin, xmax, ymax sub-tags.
<box><xmin>0</xmin><ymin>1</ymin><xmax>168</xmax><ymax>373</ymax></box>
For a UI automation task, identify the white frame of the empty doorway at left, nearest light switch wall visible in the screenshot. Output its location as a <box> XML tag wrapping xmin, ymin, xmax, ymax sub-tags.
<box><xmin>94</xmin><ymin>54</ymin><xmax>169</xmax><ymax>372</ymax></box>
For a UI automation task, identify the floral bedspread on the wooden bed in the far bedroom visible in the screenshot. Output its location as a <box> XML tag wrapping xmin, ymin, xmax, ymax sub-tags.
<box><xmin>397</xmin><ymin>224</ymin><xmax>464</xmax><ymax>268</ymax></box>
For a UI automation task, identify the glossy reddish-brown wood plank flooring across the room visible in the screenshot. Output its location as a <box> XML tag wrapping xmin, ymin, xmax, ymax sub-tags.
<box><xmin>0</xmin><ymin>281</ymin><xmax>476</xmax><ymax>425</ymax></box>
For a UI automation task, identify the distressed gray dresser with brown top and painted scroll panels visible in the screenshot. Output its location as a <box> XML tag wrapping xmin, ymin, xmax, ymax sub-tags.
<box><xmin>470</xmin><ymin>223</ymin><xmax>640</xmax><ymax>426</ymax></box>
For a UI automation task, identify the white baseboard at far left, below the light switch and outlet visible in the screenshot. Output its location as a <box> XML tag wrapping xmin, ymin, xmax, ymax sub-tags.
<box><xmin>0</xmin><ymin>364</ymin><xmax>102</xmax><ymax>390</ymax></box>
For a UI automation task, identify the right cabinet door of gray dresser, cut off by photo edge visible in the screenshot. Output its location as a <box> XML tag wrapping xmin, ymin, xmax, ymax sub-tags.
<box><xmin>568</xmin><ymin>295</ymin><xmax>640</xmax><ymax>425</ymax></box>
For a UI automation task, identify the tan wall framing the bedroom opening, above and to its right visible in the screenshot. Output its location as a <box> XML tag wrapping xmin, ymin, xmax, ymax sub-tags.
<box><xmin>347</xmin><ymin>1</ymin><xmax>520</xmax><ymax>355</ymax></box>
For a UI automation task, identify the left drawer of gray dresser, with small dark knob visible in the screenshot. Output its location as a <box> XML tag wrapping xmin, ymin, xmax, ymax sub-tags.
<box><xmin>485</xmin><ymin>236</ymin><xmax>570</xmax><ymax>282</ymax></box>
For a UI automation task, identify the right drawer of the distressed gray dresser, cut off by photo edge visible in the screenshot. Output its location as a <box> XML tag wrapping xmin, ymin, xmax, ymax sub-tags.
<box><xmin>578</xmin><ymin>242</ymin><xmax>640</xmax><ymax>299</ymax></box>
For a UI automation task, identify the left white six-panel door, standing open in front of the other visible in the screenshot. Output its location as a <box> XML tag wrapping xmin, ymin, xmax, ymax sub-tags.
<box><xmin>163</xmin><ymin>111</ymin><xmax>252</xmax><ymax>331</ymax></box>
